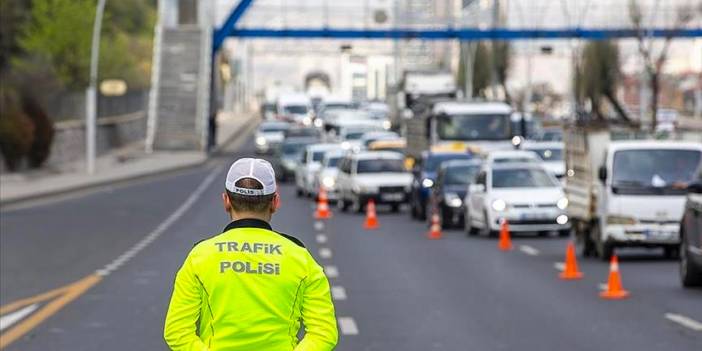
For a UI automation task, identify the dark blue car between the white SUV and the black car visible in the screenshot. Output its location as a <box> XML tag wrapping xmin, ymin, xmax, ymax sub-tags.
<box><xmin>409</xmin><ymin>151</ymin><xmax>474</xmax><ymax>220</ymax></box>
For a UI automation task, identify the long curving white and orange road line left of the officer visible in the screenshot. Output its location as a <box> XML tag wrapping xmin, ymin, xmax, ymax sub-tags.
<box><xmin>0</xmin><ymin>166</ymin><xmax>222</xmax><ymax>349</ymax></box>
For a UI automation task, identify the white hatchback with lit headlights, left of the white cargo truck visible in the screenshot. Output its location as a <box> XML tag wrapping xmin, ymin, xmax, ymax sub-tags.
<box><xmin>464</xmin><ymin>163</ymin><xmax>570</xmax><ymax>236</ymax></box>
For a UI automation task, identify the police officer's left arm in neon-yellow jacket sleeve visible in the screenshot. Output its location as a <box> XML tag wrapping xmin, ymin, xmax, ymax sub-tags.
<box><xmin>163</xmin><ymin>256</ymin><xmax>207</xmax><ymax>351</ymax></box>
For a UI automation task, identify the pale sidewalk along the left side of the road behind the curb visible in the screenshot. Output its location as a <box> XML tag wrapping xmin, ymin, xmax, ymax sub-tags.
<box><xmin>0</xmin><ymin>113</ymin><xmax>258</xmax><ymax>206</ymax></box>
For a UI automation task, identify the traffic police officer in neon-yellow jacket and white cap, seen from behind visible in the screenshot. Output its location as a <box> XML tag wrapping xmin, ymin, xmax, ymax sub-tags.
<box><xmin>164</xmin><ymin>158</ymin><xmax>338</xmax><ymax>351</ymax></box>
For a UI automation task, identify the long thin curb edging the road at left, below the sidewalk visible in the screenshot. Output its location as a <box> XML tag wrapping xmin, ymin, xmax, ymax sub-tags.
<box><xmin>0</xmin><ymin>116</ymin><xmax>256</xmax><ymax>209</ymax></box>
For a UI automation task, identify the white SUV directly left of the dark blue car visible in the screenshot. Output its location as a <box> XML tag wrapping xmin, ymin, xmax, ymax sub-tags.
<box><xmin>337</xmin><ymin>151</ymin><xmax>412</xmax><ymax>212</ymax></box>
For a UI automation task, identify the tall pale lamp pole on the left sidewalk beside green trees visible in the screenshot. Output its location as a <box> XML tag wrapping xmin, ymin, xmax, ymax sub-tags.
<box><xmin>85</xmin><ymin>0</ymin><xmax>107</xmax><ymax>174</ymax></box>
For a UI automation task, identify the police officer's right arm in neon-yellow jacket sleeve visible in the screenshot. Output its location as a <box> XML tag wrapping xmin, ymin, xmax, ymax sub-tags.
<box><xmin>295</xmin><ymin>256</ymin><xmax>339</xmax><ymax>351</ymax></box>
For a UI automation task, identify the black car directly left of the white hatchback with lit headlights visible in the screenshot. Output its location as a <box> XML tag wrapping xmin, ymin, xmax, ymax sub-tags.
<box><xmin>429</xmin><ymin>159</ymin><xmax>482</xmax><ymax>228</ymax></box>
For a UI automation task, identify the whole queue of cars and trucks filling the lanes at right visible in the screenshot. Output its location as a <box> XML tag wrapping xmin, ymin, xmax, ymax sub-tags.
<box><xmin>255</xmin><ymin>93</ymin><xmax>702</xmax><ymax>286</ymax></box>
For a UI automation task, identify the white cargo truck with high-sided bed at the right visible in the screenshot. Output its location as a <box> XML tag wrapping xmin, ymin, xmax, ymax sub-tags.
<box><xmin>564</xmin><ymin>126</ymin><xmax>702</xmax><ymax>260</ymax></box>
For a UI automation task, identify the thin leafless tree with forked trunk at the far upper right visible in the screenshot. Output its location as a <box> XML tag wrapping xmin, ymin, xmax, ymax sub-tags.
<box><xmin>629</xmin><ymin>0</ymin><xmax>702</xmax><ymax>130</ymax></box>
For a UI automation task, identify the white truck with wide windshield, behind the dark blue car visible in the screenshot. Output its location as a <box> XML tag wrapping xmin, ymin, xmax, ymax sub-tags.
<box><xmin>403</xmin><ymin>100</ymin><xmax>515</xmax><ymax>159</ymax></box>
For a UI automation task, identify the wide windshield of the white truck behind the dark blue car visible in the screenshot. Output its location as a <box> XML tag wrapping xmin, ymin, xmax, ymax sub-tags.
<box><xmin>437</xmin><ymin>115</ymin><xmax>512</xmax><ymax>140</ymax></box>
